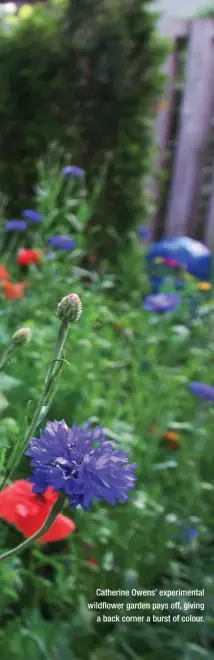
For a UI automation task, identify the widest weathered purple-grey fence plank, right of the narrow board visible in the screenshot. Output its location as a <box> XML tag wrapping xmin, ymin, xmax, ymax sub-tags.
<box><xmin>165</xmin><ymin>19</ymin><xmax>214</xmax><ymax>236</ymax></box>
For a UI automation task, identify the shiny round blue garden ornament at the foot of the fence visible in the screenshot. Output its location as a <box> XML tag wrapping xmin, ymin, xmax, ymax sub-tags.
<box><xmin>146</xmin><ymin>236</ymin><xmax>212</xmax><ymax>290</ymax></box>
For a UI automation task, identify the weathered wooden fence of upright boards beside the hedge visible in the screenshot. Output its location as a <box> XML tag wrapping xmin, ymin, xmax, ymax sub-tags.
<box><xmin>150</xmin><ymin>17</ymin><xmax>214</xmax><ymax>253</ymax></box>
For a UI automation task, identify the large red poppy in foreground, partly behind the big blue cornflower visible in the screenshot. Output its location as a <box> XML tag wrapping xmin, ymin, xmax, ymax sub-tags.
<box><xmin>0</xmin><ymin>479</ymin><xmax>76</xmax><ymax>543</ymax></box>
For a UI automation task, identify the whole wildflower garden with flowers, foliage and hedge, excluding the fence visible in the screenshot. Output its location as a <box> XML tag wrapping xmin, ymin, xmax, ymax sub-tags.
<box><xmin>0</xmin><ymin>0</ymin><xmax>214</xmax><ymax>660</ymax></box>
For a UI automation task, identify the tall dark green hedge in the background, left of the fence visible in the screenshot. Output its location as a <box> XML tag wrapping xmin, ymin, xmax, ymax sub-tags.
<box><xmin>0</xmin><ymin>0</ymin><xmax>165</xmax><ymax>262</ymax></box>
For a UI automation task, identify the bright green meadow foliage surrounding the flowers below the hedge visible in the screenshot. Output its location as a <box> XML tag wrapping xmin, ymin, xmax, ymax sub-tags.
<box><xmin>0</xmin><ymin>229</ymin><xmax>214</xmax><ymax>660</ymax></box>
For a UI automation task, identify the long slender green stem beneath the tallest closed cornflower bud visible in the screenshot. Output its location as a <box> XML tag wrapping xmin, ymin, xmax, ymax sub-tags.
<box><xmin>0</xmin><ymin>322</ymin><xmax>68</xmax><ymax>489</ymax></box>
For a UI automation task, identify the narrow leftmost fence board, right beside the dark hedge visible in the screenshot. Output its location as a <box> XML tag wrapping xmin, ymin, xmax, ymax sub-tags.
<box><xmin>148</xmin><ymin>16</ymin><xmax>189</xmax><ymax>233</ymax></box>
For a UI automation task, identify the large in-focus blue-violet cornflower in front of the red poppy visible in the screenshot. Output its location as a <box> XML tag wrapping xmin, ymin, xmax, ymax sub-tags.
<box><xmin>26</xmin><ymin>421</ymin><xmax>137</xmax><ymax>510</ymax></box>
